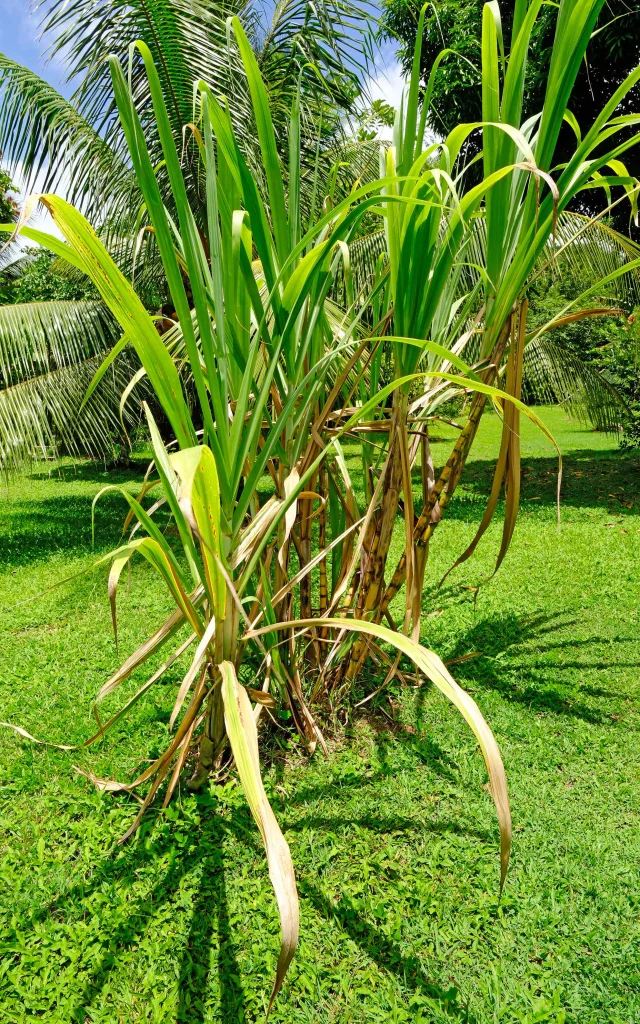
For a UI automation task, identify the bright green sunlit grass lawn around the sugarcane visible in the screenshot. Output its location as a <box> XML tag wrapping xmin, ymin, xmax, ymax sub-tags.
<box><xmin>0</xmin><ymin>410</ymin><xmax>640</xmax><ymax>1024</ymax></box>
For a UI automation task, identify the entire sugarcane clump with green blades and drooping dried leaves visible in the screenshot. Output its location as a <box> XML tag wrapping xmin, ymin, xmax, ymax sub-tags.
<box><xmin>4</xmin><ymin>0</ymin><xmax>640</xmax><ymax>1009</ymax></box>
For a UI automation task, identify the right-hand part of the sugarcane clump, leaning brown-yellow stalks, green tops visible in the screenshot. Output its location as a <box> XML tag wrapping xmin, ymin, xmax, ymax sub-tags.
<box><xmin>327</xmin><ymin>3</ymin><xmax>639</xmax><ymax>680</ymax></box>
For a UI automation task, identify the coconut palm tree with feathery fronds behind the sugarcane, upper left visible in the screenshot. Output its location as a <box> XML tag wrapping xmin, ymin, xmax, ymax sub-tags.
<box><xmin>0</xmin><ymin>0</ymin><xmax>377</xmax><ymax>467</ymax></box>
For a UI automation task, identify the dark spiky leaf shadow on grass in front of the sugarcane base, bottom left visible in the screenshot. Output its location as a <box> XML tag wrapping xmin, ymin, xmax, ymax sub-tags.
<box><xmin>11</xmin><ymin>761</ymin><xmax>499</xmax><ymax>1024</ymax></box>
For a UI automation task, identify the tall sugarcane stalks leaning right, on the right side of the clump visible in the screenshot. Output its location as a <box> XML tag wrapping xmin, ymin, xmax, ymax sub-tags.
<box><xmin>345</xmin><ymin>0</ymin><xmax>640</xmax><ymax>678</ymax></box>
